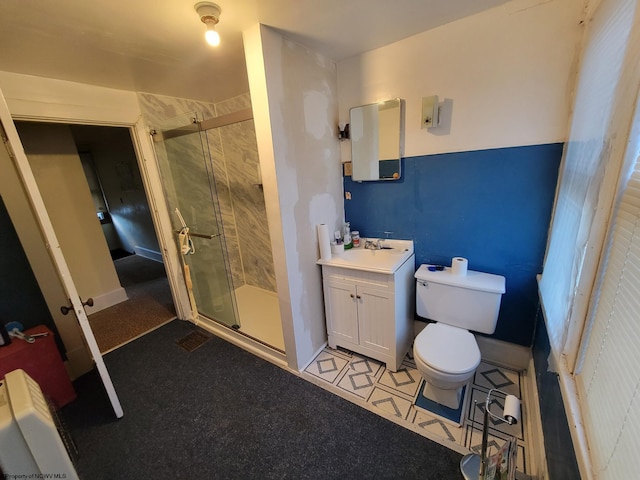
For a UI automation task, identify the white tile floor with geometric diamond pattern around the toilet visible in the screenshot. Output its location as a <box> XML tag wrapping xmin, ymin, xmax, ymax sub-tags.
<box><xmin>303</xmin><ymin>347</ymin><xmax>528</xmax><ymax>474</ymax></box>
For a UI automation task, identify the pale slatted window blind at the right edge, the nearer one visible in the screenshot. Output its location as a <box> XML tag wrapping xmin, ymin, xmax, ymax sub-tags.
<box><xmin>576</xmin><ymin>157</ymin><xmax>640</xmax><ymax>479</ymax></box>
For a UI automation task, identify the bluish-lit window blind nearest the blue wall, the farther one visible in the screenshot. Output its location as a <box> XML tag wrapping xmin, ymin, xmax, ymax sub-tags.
<box><xmin>540</xmin><ymin>0</ymin><xmax>636</xmax><ymax>356</ymax></box>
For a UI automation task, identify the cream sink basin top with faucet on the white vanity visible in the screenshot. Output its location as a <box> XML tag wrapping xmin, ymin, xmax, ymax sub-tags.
<box><xmin>318</xmin><ymin>239</ymin><xmax>413</xmax><ymax>273</ymax></box>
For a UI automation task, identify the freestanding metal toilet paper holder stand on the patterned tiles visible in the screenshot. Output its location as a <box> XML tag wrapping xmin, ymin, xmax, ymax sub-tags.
<box><xmin>460</xmin><ymin>388</ymin><xmax>520</xmax><ymax>480</ymax></box>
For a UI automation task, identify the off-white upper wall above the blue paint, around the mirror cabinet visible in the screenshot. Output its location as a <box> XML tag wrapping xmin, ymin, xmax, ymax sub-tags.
<box><xmin>338</xmin><ymin>0</ymin><xmax>584</xmax><ymax>161</ymax></box>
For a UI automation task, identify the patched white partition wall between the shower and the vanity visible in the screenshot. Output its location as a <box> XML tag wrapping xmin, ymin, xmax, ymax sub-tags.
<box><xmin>243</xmin><ymin>25</ymin><xmax>343</xmax><ymax>369</ymax></box>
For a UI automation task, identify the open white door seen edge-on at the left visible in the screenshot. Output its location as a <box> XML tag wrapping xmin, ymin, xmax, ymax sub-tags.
<box><xmin>0</xmin><ymin>91</ymin><xmax>123</xmax><ymax>418</ymax></box>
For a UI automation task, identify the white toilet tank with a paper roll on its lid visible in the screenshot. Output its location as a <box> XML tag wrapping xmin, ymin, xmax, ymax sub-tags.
<box><xmin>415</xmin><ymin>265</ymin><xmax>505</xmax><ymax>333</ymax></box>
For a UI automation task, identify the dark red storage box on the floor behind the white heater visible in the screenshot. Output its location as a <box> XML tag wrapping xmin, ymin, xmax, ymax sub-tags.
<box><xmin>0</xmin><ymin>325</ymin><xmax>76</xmax><ymax>408</ymax></box>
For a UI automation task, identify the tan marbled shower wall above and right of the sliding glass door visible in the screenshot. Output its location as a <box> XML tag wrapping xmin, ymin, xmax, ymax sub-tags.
<box><xmin>138</xmin><ymin>93</ymin><xmax>276</xmax><ymax>292</ymax></box>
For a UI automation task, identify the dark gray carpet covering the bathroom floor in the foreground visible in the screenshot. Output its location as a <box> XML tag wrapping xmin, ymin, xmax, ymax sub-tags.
<box><xmin>62</xmin><ymin>320</ymin><xmax>462</xmax><ymax>480</ymax></box>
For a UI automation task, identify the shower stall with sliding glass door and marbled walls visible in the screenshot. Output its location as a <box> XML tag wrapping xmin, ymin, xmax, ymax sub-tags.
<box><xmin>153</xmin><ymin>110</ymin><xmax>284</xmax><ymax>352</ymax></box>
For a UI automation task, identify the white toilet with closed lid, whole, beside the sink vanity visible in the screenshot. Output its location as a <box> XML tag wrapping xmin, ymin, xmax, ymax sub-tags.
<box><xmin>413</xmin><ymin>265</ymin><xmax>505</xmax><ymax>409</ymax></box>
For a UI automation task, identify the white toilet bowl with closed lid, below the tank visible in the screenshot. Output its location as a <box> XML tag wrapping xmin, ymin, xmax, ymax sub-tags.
<box><xmin>413</xmin><ymin>323</ymin><xmax>480</xmax><ymax>410</ymax></box>
